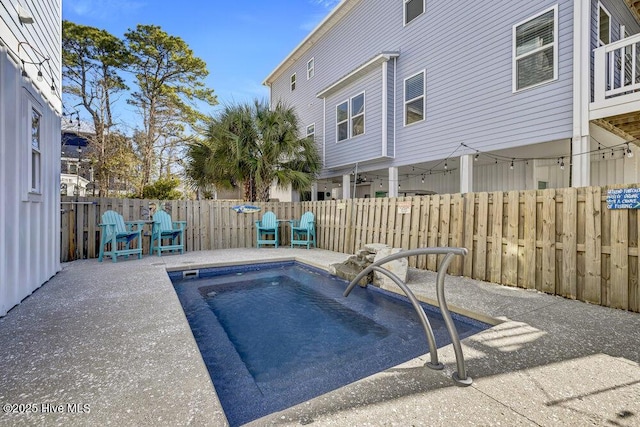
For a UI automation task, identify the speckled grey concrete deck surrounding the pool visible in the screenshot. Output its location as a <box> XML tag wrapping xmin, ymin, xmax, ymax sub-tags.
<box><xmin>0</xmin><ymin>248</ymin><xmax>640</xmax><ymax>426</ymax></box>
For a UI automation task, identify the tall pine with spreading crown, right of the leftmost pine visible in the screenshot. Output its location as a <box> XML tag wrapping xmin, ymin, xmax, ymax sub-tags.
<box><xmin>125</xmin><ymin>25</ymin><xmax>217</xmax><ymax>194</ymax></box>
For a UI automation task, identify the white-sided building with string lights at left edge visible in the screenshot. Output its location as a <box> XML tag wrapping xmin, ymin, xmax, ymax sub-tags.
<box><xmin>0</xmin><ymin>0</ymin><xmax>62</xmax><ymax>316</ymax></box>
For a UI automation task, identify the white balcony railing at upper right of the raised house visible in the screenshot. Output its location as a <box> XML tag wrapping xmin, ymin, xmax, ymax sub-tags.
<box><xmin>590</xmin><ymin>34</ymin><xmax>640</xmax><ymax>118</ymax></box>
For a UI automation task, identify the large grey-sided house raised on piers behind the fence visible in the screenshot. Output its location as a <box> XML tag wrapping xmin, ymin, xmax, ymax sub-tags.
<box><xmin>264</xmin><ymin>0</ymin><xmax>640</xmax><ymax>198</ymax></box>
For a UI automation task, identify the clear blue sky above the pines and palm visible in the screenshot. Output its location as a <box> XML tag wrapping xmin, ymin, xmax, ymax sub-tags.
<box><xmin>62</xmin><ymin>0</ymin><xmax>340</xmax><ymax>125</ymax></box>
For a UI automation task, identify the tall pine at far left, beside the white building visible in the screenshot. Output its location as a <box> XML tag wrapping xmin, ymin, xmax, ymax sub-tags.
<box><xmin>62</xmin><ymin>21</ymin><xmax>131</xmax><ymax>196</ymax></box>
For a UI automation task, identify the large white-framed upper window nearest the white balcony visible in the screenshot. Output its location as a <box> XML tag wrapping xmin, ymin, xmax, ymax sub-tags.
<box><xmin>513</xmin><ymin>6</ymin><xmax>558</xmax><ymax>92</ymax></box>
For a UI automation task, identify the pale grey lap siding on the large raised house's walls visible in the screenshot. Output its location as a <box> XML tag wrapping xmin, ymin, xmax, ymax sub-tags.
<box><xmin>273</xmin><ymin>0</ymin><xmax>573</xmax><ymax>176</ymax></box>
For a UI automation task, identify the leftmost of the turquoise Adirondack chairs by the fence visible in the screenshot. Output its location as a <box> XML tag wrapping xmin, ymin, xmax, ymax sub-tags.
<box><xmin>98</xmin><ymin>211</ymin><xmax>142</xmax><ymax>262</ymax></box>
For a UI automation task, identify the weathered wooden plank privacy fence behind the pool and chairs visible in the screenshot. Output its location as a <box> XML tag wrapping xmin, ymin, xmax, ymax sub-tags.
<box><xmin>62</xmin><ymin>187</ymin><xmax>640</xmax><ymax>312</ymax></box>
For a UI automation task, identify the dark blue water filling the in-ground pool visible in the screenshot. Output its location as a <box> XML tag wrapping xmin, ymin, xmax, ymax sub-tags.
<box><xmin>170</xmin><ymin>262</ymin><xmax>489</xmax><ymax>426</ymax></box>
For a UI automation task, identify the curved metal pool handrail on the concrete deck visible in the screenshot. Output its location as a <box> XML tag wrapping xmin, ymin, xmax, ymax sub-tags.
<box><xmin>343</xmin><ymin>247</ymin><xmax>473</xmax><ymax>387</ymax></box>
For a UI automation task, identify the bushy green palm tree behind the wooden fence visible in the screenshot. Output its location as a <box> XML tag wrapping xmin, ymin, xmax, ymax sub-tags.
<box><xmin>185</xmin><ymin>101</ymin><xmax>322</xmax><ymax>201</ymax></box>
